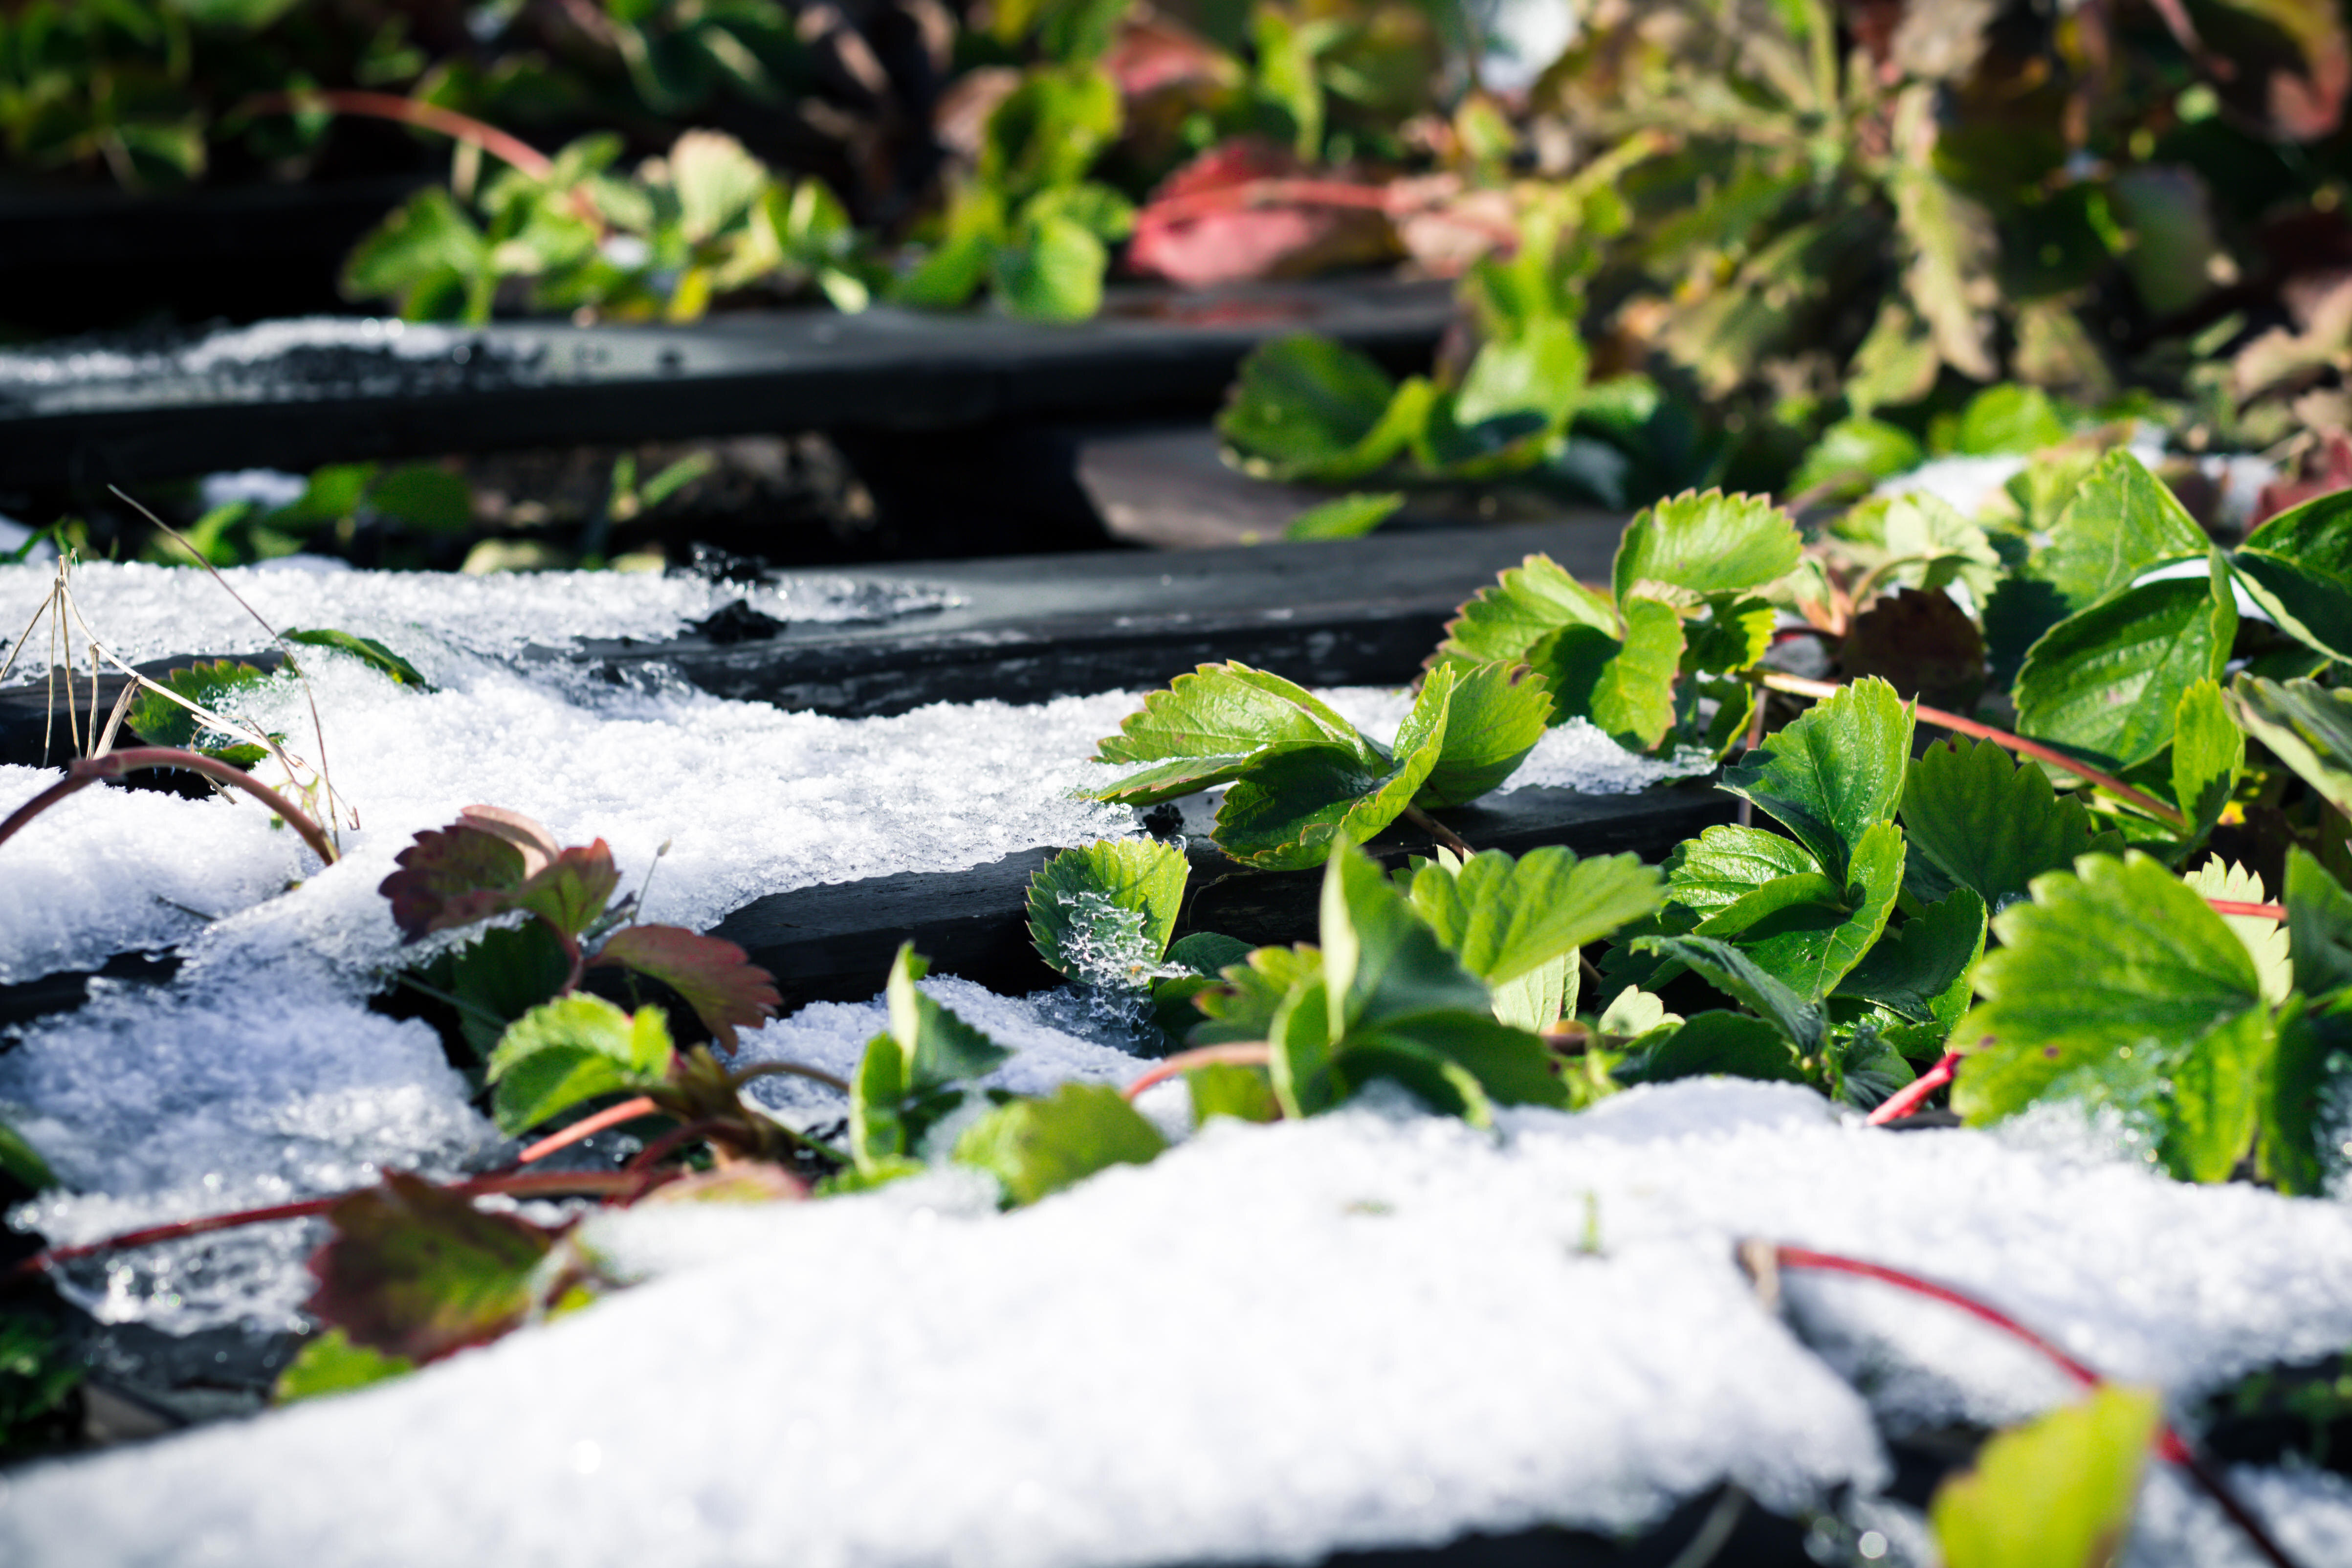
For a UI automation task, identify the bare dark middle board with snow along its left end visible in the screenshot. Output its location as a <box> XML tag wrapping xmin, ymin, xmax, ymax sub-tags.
<box><xmin>578</xmin><ymin>512</ymin><xmax>1623</xmax><ymax>717</ymax></box>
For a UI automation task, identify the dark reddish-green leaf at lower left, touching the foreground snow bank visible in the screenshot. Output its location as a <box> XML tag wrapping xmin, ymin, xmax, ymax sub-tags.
<box><xmin>308</xmin><ymin>1170</ymin><xmax>555</xmax><ymax>1361</ymax></box>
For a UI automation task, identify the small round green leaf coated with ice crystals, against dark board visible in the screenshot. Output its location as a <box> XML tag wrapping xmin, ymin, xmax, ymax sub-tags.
<box><xmin>1028</xmin><ymin>839</ymin><xmax>1190</xmax><ymax>990</ymax></box>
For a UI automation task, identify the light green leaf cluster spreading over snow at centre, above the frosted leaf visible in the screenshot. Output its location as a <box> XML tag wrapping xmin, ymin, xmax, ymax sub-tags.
<box><xmin>1094</xmin><ymin>661</ymin><xmax>1550</xmax><ymax>870</ymax></box>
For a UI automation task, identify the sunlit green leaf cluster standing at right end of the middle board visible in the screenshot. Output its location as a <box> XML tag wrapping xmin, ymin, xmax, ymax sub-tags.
<box><xmin>1432</xmin><ymin>491</ymin><xmax>1804</xmax><ymax>757</ymax></box>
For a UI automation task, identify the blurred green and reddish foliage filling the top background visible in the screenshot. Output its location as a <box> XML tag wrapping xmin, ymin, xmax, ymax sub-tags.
<box><xmin>14</xmin><ymin>0</ymin><xmax>2352</xmax><ymax>531</ymax></box>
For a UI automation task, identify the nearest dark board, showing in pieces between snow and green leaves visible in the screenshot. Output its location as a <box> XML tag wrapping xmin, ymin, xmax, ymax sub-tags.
<box><xmin>713</xmin><ymin>780</ymin><xmax>1738</xmax><ymax>1006</ymax></box>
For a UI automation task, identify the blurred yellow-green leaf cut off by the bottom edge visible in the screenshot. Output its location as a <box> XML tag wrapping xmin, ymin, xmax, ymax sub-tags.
<box><xmin>1929</xmin><ymin>1382</ymin><xmax>2161</xmax><ymax>1568</ymax></box>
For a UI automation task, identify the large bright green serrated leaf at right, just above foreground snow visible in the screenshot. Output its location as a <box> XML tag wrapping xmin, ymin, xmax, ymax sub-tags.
<box><xmin>1952</xmin><ymin>851</ymin><xmax>2270</xmax><ymax>1180</ymax></box>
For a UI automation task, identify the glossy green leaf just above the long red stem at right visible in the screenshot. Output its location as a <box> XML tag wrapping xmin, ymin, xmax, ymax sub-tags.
<box><xmin>2016</xmin><ymin>557</ymin><xmax>2237</xmax><ymax>769</ymax></box>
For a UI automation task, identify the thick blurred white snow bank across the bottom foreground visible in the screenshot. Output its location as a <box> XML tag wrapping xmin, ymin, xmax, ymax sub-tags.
<box><xmin>0</xmin><ymin>1086</ymin><xmax>2352</xmax><ymax>1568</ymax></box>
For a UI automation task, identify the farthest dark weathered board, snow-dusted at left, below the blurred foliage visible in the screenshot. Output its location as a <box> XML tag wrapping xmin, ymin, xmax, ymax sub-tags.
<box><xmin>0</xmin><ymin>282</ymin><xmax>1451</xmax><ymax>486</ymax></box>
